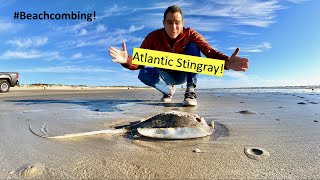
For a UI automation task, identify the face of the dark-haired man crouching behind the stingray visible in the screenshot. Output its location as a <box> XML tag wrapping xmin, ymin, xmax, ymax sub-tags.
<box><xmin>163</xmin><ymin>12</ymin><xmax>183</xmax><ymax>39</ymax></box>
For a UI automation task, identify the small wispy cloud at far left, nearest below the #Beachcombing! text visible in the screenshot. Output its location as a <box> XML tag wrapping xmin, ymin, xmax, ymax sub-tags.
<box><xmin>6</xmin><ymin>37</ymin><xmax>48</xmax><ymax>48</ymax></box>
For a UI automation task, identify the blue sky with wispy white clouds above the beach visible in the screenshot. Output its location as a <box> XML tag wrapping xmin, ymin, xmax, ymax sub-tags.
<box><xmin>0</xmin><ymin>0</ymin><xmax>320</xmax><ymax>88</ymax></box>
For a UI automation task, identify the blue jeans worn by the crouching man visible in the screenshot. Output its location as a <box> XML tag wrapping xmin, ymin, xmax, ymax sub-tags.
<box><xmin>138</xmin><ymin>43</ymin><xmax>200</xmax><ymax>95</ymax></box>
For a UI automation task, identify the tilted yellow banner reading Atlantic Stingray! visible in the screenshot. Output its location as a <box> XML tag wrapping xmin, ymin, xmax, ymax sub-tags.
<box><xmin>132</xmin><ymin>48</ymin><xmax>225</xmax><ymax>77</ymax></box>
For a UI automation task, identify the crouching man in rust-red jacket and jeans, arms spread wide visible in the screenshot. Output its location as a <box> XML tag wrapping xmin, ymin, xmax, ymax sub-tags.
<box><xmin>109</xmin><ymin>5</ymin><xmax>248</xmax><ymax>106</ymax></box>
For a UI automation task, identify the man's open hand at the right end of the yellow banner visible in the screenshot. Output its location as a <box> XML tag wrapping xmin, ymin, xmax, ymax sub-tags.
<box><xmin>226</xmin><ymin>48</ymin><xmax>248</xmax><ymax>72</ymax></box>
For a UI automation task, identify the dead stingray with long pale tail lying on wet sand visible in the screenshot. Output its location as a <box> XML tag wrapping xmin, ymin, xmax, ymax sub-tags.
<box><xmin>29</xmin><ymin>111</ymin><xmax>214</xmax><ymax>139</ymax></box>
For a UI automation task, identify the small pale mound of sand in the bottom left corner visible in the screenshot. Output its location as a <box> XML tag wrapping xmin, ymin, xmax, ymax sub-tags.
<box><xmin>8</xmin><ymin>163</ymin><xmax>46</xmax><ymax>179</ymax></box>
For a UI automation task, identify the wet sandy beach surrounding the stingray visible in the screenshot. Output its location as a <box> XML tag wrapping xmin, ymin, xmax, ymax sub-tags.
<box><xmin>0</xmin><ymin>87</ymin><xmax>320</xmax><ymax>179</ymax></box>
